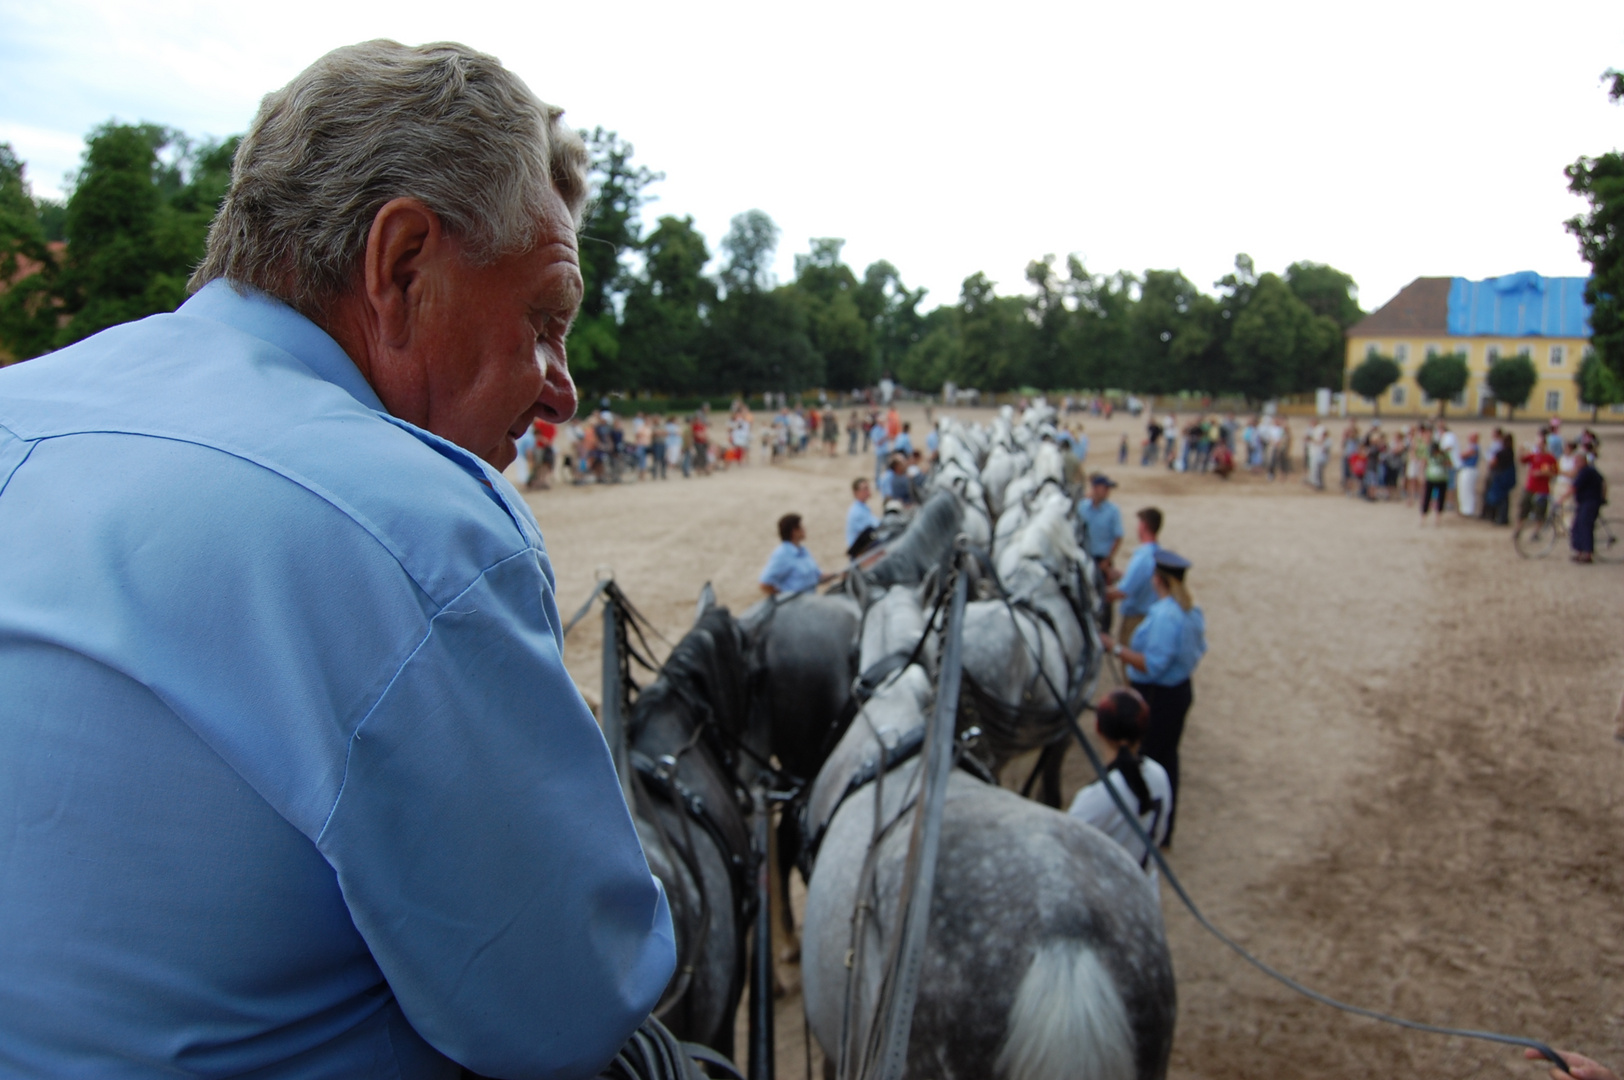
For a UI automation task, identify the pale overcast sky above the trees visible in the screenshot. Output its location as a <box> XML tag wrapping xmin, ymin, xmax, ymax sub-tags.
<box><xmin>0</xmin><ymin>0</ymin><xmax>1624</xmax><ymax>310</ymax></box>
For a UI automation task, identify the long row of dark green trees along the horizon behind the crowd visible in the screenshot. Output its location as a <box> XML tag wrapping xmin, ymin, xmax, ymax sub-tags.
<box><xmin>0</xmin><ymin>123</ymin><xmax>1363</xmax><ymax>400</ymax></box>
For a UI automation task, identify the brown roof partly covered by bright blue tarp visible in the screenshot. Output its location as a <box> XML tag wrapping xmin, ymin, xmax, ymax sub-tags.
<box><xmin>1348</xmin><ymin>270</ymin><xmax>1590</xmax><ymax>338</ymax></box>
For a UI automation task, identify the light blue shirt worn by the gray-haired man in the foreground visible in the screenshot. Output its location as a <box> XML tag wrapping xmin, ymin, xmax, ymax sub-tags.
<box><xmin>0</xmin><ymin>283</ymin><xmax>674</xmax><ymax>1078</ymax></box>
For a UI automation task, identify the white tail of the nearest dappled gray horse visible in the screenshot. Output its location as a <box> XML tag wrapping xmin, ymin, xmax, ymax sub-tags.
<box><xmin>997</xmin><ymin>937</ymin><xmax>1135</xmax><ymax>1080</ymax></box>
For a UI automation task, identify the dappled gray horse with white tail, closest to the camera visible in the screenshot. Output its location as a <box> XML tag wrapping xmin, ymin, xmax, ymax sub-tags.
<box><xmin>802</xmin><ymin>588</ymin><xmax>1174</xmax><ymax>1080</ymax></box>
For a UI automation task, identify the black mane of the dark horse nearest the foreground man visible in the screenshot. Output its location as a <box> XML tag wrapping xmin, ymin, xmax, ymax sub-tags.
<box><xmin>628</xmin><ymin>604</ymin><xmax>750</xmax><ymax>742</ymax></box>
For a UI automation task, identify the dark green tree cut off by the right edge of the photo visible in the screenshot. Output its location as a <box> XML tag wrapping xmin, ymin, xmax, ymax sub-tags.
<box><xmin>1566</xmin><ymin>70</ymin><xmax>1624</xmax><ymax>375</ymax></box>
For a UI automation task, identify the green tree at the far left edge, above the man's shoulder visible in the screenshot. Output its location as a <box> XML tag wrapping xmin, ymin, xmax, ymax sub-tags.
<box><xmin>0</xmin><ymin>143</ymin><xmax>57</xmax><ymax>364</ymax></box>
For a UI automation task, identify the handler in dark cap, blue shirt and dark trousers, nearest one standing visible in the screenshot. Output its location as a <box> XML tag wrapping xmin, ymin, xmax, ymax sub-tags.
<box><xmin>1099</xmin><ymin>547</ymin><xmax>1207</xmax><ymax>848</ymax></box>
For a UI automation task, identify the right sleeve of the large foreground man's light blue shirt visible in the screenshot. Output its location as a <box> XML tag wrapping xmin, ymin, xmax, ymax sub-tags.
<box><xmin>317</xmin><ymin>549</ymin><xmax>676</xmax><ymax>1078</ymax></box>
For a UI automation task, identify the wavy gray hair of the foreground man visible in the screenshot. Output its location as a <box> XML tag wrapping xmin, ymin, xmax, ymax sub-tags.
<box><xmin>190</xmin><ymin>41</ymin><xmax>588</xmax><ymax>317</ymax></box>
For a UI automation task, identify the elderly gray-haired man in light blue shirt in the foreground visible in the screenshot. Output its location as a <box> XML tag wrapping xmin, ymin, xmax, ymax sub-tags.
<box><xmin>0</xmin><ymin>42</ymin><xmax>674</xmax><ymax>1077</ymax></box>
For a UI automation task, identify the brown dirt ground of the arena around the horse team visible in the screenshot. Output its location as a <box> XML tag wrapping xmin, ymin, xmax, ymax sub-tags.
<box><xmin>529</xmin><ymin>411</ymin><xmax>1624</xmax><ymax>1078</ymax></box>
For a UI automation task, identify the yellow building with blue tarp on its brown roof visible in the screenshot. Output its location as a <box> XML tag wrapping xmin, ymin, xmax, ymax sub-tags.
<box><xmin>1343</xmin><ymin>273</ymin><xmax>1604</xmax><ymax>421</ymax></box>
